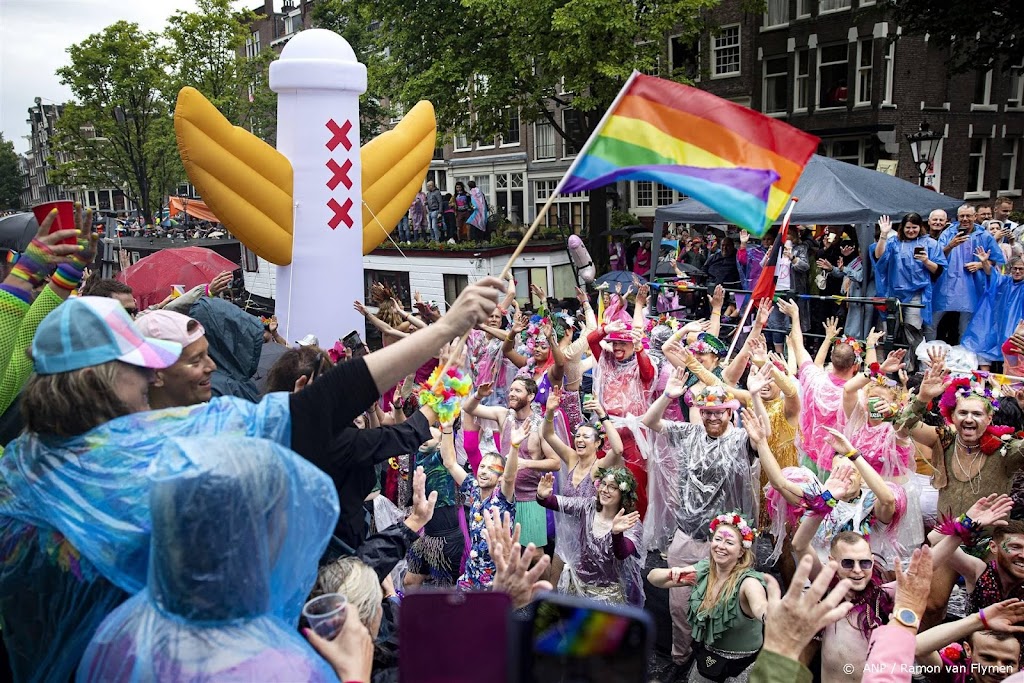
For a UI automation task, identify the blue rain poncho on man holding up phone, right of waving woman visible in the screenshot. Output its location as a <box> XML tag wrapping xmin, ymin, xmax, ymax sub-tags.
<box><xmin>932</xmin><ymin>222</ymin><xmax>1007</xmax><ymax>313</ymax></box>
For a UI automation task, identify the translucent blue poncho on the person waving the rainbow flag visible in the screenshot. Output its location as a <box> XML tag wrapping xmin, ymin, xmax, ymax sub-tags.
<box><xmin>0</xmin><ymin>393</ymin><xmax>291</xmax><ymax>681</ymax></box>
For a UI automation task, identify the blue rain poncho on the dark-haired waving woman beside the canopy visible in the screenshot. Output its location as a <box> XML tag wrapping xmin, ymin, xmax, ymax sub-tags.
<box><xmin>871</xmin><ymin>234</ymin><xmax>946</xmax><ymax>325</ymax></box>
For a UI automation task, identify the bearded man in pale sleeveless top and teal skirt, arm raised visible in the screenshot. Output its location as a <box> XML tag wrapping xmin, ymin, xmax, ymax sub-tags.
<box><xmin>462</xmin><ymin>377</ymin><xmax>568</xmax><ymax>548</ymax></box>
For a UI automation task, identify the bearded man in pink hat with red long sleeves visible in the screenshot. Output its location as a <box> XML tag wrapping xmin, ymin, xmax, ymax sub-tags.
<box><xmin>587</xmin><ymin>322</ymin><xmax>656</xmax><ymax>519</ymax></box>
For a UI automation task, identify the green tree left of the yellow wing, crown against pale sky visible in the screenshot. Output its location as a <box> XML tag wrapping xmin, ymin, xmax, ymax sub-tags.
<box><xmin>51</xmin><ymin>20</ymin><xmax>176</xmax><ymax>222</ymax></box>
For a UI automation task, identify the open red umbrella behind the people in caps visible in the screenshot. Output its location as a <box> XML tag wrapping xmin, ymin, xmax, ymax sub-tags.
<box><xmin>117</xmin><ymin>247</ymin><xmax>239</xmax><ymax>309</ymax></box>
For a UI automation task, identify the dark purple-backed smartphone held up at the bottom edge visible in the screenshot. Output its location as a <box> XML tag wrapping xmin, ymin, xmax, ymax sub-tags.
<box><xmin>398</xmin><ymin>591</ymin><xmax>512</xmax><ymax>683</ymax></box>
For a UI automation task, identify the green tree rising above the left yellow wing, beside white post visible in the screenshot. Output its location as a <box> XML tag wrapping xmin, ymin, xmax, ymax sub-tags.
<box><xmin>164</xmin><ymin>0</ymin><xmax>276</xmax><ymax>141</ymax></box>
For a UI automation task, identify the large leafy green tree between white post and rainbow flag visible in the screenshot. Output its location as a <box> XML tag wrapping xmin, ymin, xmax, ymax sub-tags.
<box><xmin>372</xmin><ymin>0</ymin><xmax>718</xmax><ymax>258</ymax></box>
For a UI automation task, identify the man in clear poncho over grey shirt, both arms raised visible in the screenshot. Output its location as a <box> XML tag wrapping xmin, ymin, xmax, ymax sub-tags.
<box><xmin>641</xmin><ymin>369</ymin><xmax>771</xmax><ymax>665</ymax></box>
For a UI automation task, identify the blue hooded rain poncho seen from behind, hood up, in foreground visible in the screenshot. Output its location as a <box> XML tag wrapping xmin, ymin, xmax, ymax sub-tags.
<box><xmin>78</xmin><ymin>437</ymin><xmax>338</xmax><ymax>682</ymax></box>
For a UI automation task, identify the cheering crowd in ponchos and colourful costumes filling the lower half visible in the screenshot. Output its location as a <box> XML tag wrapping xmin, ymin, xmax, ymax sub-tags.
<box><xmin>0</xmin><ymin>204</ymin><xmax>1024</xmax><ymax>683</ymax></box>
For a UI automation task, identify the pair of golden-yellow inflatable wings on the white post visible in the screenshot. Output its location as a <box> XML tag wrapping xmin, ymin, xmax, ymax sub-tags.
<box><xmin>174</xmin><ymin>88</ymin><xmax>436</xmax><ymax>265</ymax></box>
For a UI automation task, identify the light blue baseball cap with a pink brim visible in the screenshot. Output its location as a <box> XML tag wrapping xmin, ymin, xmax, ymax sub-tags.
<box><xmin>32</xmin><ymin>297</ymin><xmax>181</xmax><ymax>375</ymax></box>
